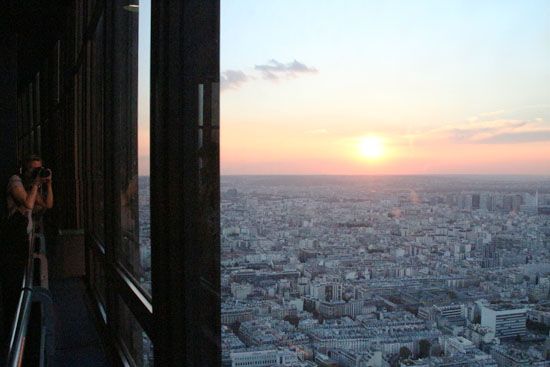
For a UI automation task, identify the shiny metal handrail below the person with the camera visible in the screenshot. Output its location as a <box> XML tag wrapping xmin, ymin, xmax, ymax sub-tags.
<box><xmin>6</xmin><ymin>221</ymin><xmax>54</xmax><ymax>367</ymax></box>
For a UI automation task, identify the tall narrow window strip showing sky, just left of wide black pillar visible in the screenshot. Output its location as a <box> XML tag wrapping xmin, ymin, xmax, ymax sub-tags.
<box><xmin>117</xmin><ymin>1</ymin><xmax>151</xmax><ymax>296</ymax></box>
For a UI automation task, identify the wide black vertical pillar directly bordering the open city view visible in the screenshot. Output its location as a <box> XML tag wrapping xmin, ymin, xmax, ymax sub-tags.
<box><xmin>150</xmin><ymin>0</ymin><xmax>221</xmax><ymax>367</ymax></box>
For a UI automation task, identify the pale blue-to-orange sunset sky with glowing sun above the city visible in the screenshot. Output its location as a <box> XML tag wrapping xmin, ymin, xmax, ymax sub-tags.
<box><xmin>140</xmin><ymin>0</ymin><xmax>550</xmax><ymax>174</ymax></box>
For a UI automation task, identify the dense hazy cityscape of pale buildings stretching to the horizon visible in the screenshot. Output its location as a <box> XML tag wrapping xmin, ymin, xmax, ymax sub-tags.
<box><xmin>221</xmin><ymin>176</ymin><xmax>550</xmax><ymax>367</ymax></box>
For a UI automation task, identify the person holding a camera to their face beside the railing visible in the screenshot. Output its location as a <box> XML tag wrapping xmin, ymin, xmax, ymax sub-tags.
<box><xmin>0</xmin><ymin>155</ymin><xmax>53</xmax><ymax>347</ymax></box>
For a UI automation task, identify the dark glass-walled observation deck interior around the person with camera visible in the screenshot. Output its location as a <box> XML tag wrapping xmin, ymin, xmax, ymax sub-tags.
<box><xmin>0</xmin><ymin>0</ymin><xmax>221</xmax><ymax>367</ymax></box>
